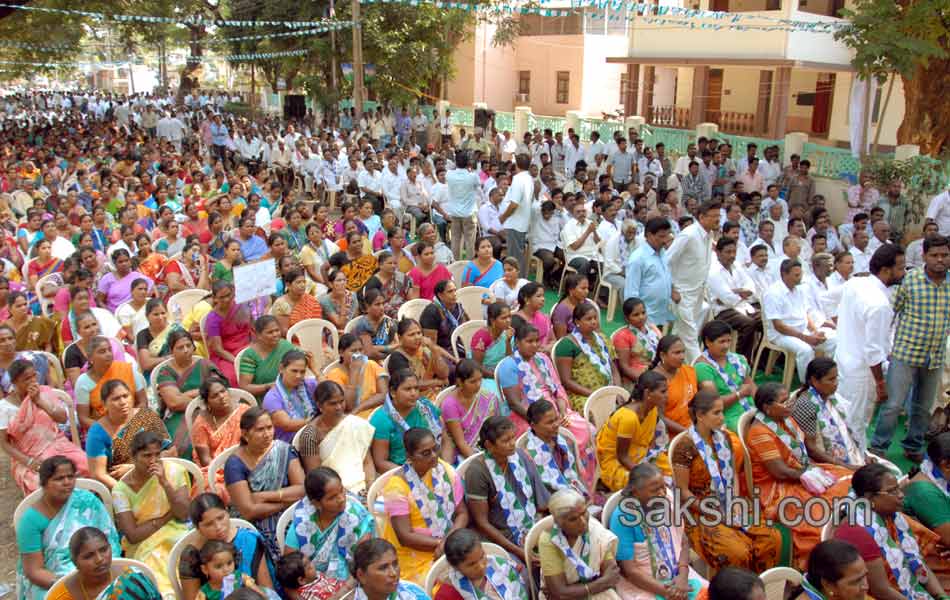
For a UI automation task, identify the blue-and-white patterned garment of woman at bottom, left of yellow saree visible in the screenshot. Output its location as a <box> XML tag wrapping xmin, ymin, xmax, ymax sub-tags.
<box><xmin>286</xmin><ymin>496</ymin><xmax>376</xmax><ymax>581</ymax></box>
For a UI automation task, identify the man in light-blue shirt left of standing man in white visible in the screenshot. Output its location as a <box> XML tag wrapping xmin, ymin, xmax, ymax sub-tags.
<box><xmin>623</xmin><ymin>217</ymin><xmax>674</xmax><ymax>327</ymax></box>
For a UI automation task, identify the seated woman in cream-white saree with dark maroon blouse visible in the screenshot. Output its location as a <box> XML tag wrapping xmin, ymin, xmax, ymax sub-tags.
<box><xmin>297</xmin><ymin>381</ymin><xmax>376</xmax><ymax>494</ymax></box>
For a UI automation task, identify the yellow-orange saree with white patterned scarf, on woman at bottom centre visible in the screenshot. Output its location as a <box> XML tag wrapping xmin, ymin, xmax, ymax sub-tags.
<box><xmin>382</xmin><ymin>459</ymin><xmax>465</xmax><ymax>585</ymax></box>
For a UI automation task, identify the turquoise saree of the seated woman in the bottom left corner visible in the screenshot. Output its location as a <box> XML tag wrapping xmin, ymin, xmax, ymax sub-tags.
<box><xmin>16</xmin><ymin>488</ymin><xmax>122</xmax><ymax>600</ymax></box>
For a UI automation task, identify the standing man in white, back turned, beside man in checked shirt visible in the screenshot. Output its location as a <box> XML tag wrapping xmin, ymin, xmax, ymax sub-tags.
<box><xmin>834</xmin><ymin>244</ymin><xmax>904</xmax><ymax>450</ymax></box>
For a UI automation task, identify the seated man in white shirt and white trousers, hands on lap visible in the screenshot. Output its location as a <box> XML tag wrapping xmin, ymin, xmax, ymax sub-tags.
<box><xmin>762</xmin><ymin>259</ymin><xmax>835</xmax><ymax>381</ymax></box>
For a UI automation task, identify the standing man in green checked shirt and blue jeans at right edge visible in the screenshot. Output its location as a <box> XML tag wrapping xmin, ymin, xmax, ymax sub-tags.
<box><xmin>870</xmin><ymin>235</ymin><xmax>950</xmax><ymax>463</ymax></box>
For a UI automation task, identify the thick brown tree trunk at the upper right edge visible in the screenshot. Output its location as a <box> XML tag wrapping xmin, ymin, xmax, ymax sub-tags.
<box><xmin>897</xmin><ymin>59</ymin><xmax>950</xmax><ymax>156</ymax></box>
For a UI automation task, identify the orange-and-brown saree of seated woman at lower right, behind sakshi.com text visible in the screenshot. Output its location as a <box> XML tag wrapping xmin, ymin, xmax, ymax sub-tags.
<box><xmin>746</xmin><ymin>420</ymin><xmax>852</xmax><ymax>570</ymax></box>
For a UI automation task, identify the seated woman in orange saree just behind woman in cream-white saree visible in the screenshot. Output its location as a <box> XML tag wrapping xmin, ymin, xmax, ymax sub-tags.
<box><xmin>326</xmin><ymin>333</ymin><xmax>389</xmax><ymax>419</ymax></box>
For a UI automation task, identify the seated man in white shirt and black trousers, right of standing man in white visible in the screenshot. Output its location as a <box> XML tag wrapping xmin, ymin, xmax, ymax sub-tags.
<box><xmin>708</xmin><ymin>236</ymin><xmax>762</xmax><ymax>365</ymax></box>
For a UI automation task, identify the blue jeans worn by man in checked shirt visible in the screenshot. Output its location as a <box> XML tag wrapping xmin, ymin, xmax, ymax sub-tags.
<box><xmin>870</xmin><ymin>358</ymin><xmax>942</xmax><ymax>456</ymax></box>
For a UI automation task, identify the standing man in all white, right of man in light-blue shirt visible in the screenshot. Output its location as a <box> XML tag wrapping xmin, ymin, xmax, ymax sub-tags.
<box><xmin>667</xmin><ymin>200</ymin><xmax>722</xmax><ymax>364</ymax></box>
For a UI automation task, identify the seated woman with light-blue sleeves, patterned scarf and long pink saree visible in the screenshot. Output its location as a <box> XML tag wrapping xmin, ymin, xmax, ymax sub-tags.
<box><xmin>498</xmin><ymin>323</ymin><xmax>597</xmax><ymax>491</ymax></box>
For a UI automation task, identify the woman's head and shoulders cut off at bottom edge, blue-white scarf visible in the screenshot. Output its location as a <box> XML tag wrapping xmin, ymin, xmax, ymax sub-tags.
<box><xmin>353</xmin><ymin>538</ymin><xmax>429</xmax><ymax>600</ymax></box>
